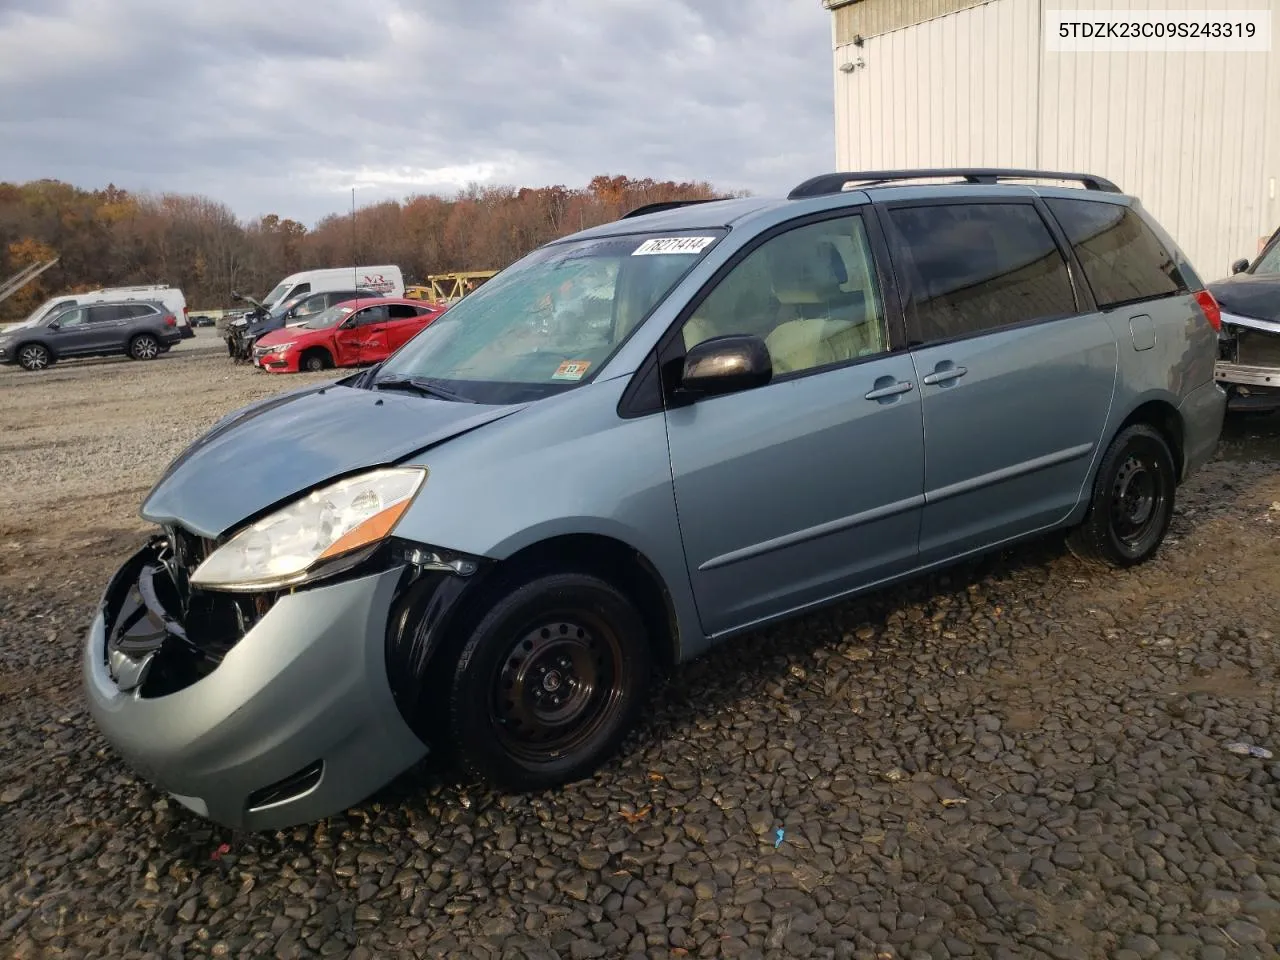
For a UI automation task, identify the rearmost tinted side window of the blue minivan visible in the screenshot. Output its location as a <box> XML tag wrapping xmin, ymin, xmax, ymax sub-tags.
<box><xmin>1046</xmin><ymin>200</ymin><xmax>1188</xmax><ymax>307</ymax></box>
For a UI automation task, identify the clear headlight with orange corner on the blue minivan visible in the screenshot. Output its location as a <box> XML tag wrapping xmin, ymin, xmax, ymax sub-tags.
<box><xmin>191</xmin><ymin>467</ymin><xmax>426</xmax><ymax>590</ymax></box>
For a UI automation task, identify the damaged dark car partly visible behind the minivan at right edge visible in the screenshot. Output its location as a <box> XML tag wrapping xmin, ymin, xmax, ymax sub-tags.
<box><xmin>1208</xmin><ymin>229</ymin><xmax>1280</xmax><ymax>413</ymax></box>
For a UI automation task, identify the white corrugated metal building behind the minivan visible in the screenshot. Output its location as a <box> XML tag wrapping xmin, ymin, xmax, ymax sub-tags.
<box><xmin>823</xmin><ymin>0</ymin><xmax>1280</xmax><ymax>280</ymax></box>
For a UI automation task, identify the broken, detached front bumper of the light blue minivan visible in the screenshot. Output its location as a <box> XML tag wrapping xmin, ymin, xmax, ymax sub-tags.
<box><xmin>83</xmin><ymin>538</ymin><xmax>426</xmax><ymax>831</ymax></box>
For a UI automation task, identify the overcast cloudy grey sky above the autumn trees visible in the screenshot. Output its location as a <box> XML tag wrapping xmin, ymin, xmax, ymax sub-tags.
<box><xmin>0</xmin><ymin>0</ymin><xmax>835</xmax><ymax>225</ymax></box>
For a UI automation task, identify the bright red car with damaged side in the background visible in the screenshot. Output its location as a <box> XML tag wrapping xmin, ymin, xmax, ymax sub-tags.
<box><xmin>253</xmin><ymin>297</ymin><xmax>448</xmax><ymax>374</ymax></box>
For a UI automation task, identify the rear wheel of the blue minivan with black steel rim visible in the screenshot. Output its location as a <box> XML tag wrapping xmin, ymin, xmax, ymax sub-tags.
<box><xmin>1066</xmin><ymin>424</ymin><xmax>1178</xmax><ymax>567</ymax></box>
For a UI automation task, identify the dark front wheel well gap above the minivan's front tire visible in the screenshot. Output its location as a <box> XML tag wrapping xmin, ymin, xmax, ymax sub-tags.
<box><xmin>495</xmin><ymin>534</ymin><xmax>680</xmax><ymax>668</ymax></box>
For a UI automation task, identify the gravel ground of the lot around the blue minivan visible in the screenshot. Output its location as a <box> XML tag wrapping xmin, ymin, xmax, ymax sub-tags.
<box><xmin>0</xmin><ymin>345</ymin><xmax>1280</xmax><ymax>960</ymax></box>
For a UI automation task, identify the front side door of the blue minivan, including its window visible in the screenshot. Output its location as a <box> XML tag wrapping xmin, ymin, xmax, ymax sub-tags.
<box><xmin>664</xmin><ymin>211</ymin><xmax>924</xmax><ymax>636</ymax></box>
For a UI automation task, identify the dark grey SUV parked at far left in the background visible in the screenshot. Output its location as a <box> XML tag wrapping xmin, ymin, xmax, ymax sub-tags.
<box><xmin>0</xmin><ymin>300</ymin><xmax>182</xmax><ymax>370</ymax></box>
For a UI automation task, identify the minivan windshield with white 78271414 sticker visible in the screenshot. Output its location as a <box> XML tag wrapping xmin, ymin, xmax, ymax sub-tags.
<box><xmin>378</xmin><ymin>230</ymin><xmax>724</xmax><ymax>403</ymax></box>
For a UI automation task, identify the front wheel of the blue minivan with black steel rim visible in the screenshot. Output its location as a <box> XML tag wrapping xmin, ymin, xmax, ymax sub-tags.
<box><xmin>448</xmin><ymin>573</ymin><xmax>652</xmax><ymax>792</ymax></box>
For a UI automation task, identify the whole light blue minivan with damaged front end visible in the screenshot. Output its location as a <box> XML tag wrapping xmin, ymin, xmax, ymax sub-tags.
<box><xmin>83</xmin><ymin>169</ymin><xmax>1225</xmax><ymax>829</ymax></box>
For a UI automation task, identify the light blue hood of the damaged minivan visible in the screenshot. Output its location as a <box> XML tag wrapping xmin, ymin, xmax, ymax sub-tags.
<box><xmin>141</xmin><ymin>384</ymin><xmax>527</xmax><ymax>539</ymax></box>
